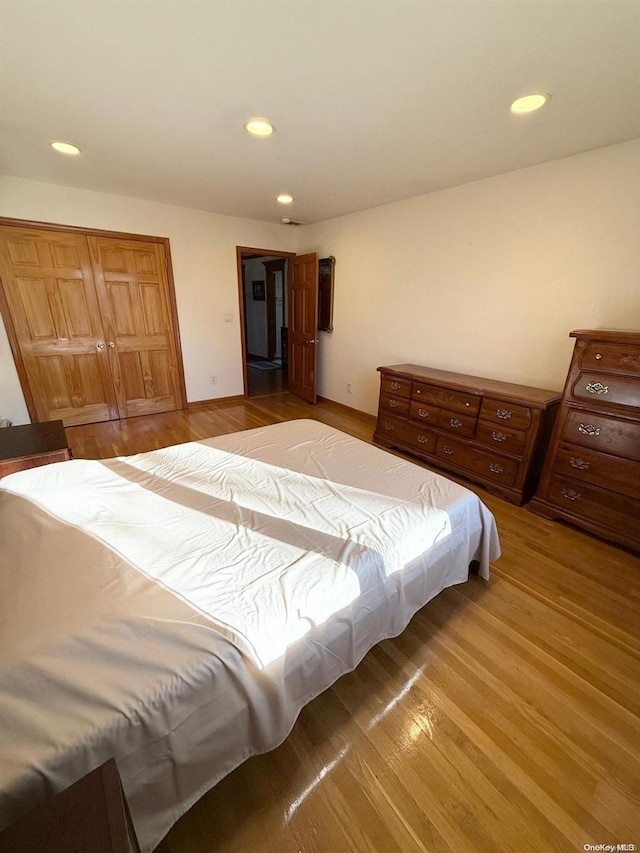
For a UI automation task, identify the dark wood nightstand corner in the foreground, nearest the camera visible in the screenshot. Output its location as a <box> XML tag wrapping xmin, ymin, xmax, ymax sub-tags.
<box><xmin>0</xmin><ymin>758</ymin><xmax>140</xmax><ymax>853</ymax></box>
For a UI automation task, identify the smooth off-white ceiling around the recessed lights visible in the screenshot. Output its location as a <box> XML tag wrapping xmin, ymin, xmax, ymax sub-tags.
<box><xmin>0</xmin><ymin>0</ymin><xmax>640</xmax><ymax>223</ymax></box>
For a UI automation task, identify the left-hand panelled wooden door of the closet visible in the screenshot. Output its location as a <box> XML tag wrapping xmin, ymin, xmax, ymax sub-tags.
<box><xmin>0</xmin><ymin>226</ymin><xmax>118</xmax><ymax>426</ymax></box>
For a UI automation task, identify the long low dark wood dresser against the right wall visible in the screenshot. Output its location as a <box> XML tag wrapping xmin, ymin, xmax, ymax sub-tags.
<box><xmin>373</xmin><ymin>364</ymin><xmax>560</xmax><ymax>504</ymax></box>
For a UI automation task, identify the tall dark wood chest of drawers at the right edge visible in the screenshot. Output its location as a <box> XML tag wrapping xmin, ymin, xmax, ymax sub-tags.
<box><xmin>529</xmin><ymin>330</ymin><xmax>640</xmax><ymax>550</ymax></box>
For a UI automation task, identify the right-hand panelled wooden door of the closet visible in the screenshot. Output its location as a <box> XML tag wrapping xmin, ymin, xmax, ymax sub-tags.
<box><xmin>89</xmin><ymin>237</ymin><xmax>182</xmax><ymax>417</ymax></box>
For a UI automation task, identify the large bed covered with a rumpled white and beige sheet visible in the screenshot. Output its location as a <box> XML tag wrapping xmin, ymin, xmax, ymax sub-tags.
<box><xmin>0</xmin><ymin>420</ymin><xmax>499</xmax><ymax>853</ymax></box>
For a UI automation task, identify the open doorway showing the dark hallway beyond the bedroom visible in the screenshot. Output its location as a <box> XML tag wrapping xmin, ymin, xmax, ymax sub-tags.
<box><xmin>237</xmin><ymin>247</ymin><xmax>292</xmax><ymax>397</ymax></box>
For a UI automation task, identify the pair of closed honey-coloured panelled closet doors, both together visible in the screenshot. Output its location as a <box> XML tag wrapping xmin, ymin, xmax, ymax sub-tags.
<box><xmin>0</xmin><ymin>225</ymin><xmax>184</xmax><ymax>426</ymax></box>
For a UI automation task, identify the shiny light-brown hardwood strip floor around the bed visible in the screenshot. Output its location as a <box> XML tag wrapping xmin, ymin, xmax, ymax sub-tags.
<box><xmin>67</xmin><ymin>393</ymin><xmax>640</xmax><ymax>853</ymax></box>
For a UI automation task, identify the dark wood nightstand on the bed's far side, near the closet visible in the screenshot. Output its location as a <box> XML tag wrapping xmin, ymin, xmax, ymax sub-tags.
<box><xmin>0</xmin><ymin>421</ymin><xmax>71</xmax><ymax>477</ymax></box>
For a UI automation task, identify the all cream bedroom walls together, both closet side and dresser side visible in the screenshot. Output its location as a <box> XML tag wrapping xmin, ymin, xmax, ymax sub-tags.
<box><xmin>0</xmin><ymin>140</ymin><xmax>640</xmax><ymax>430</ymax></box>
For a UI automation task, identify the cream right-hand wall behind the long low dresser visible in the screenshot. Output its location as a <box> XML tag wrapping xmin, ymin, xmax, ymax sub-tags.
<box><xmin>298</xmin><ymin>140</ymin><xmax>640</xmax><ymax>412</ymax></box>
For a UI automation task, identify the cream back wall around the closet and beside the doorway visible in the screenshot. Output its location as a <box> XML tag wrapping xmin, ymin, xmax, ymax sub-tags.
<box><xmin>0</xmin><ymin>176</ymin><xmax>297</xmax><ymax>423</ymax></box>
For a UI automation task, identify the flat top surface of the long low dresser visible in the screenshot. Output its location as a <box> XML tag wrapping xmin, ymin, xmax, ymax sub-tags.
<box><xmin>378</xmin><ymin>364</ymin><xmax>562</xmax><ymax>408</ymax></box>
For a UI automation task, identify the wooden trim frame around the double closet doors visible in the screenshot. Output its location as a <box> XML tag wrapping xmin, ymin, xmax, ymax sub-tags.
<box><xmin>0</xmin><ymin>216</ymin><xmax>187</xmax><ymax>423</ymax></box>
